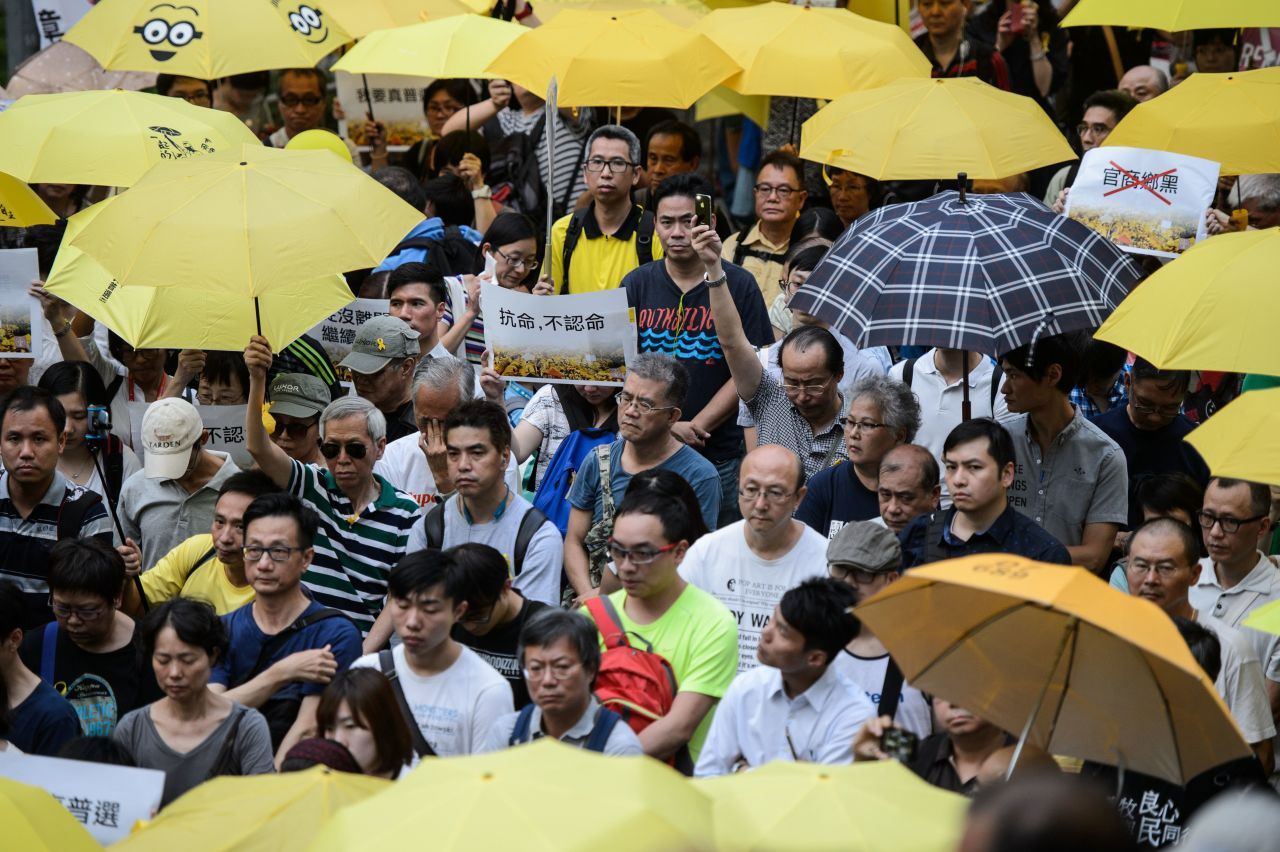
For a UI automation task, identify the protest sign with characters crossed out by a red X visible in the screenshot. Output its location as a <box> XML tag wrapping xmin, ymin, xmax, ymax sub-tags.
<box><xmin>1065</xmin><ymin>146</ymin><xmax>1219</xmax><ymax>257</ymax></box>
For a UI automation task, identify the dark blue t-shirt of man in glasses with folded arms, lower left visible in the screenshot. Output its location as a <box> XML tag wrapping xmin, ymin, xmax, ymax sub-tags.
<box><xmin>209</xmin><ymin>601</ymin><xmax>362</xmax><ymax>698</ymax></box>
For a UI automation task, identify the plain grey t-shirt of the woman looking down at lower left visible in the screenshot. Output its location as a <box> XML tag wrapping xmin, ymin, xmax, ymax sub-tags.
<box><xmin>111</xmin><ymin>704</ymin><xmax>275</xmax><ymax>807</ymax></box>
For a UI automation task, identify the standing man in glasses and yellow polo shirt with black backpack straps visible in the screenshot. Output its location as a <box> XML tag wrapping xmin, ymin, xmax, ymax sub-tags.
<box><xmin>545</xmin><ymin>124</ymin><xmax>662</xmax><ymax>293</ymax></box>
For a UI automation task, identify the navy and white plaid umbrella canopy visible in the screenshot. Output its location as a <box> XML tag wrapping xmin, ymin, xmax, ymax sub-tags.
<box><xmin>791</xmin><ymin>192</ymin><xmax>1142</xmax><ymax>356</ymax></box>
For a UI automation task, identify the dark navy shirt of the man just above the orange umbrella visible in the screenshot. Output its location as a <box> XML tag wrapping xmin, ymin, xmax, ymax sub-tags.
<box><xmin>900</xmin><ymin>507</ymin><xmax>1071</xmax><ymax>568</ymax></box>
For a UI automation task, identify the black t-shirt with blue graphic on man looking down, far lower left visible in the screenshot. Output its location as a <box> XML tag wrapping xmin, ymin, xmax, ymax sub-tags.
<box><xmin>19</xmin><ymin>622</ymin><xmax>161</xmax><ymax>737</ymax></box>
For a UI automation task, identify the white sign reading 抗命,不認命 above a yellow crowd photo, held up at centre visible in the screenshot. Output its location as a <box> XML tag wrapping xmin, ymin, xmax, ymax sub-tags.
<box><xmin>480</xmin><ymin>284</ymin><xmax>636</xmax><ymax>385</ymax></box>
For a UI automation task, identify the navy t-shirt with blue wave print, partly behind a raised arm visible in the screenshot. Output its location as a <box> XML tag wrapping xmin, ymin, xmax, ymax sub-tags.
<box><xmin>622</xmin><ymin>260</ymin><xmax>773</xmax><ymax>462</ymax></box>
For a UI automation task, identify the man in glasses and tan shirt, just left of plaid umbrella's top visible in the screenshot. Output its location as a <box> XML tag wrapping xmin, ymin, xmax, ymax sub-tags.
<box><xmin>721</xmin><ymin>151</ymin><xmax>809</xmax><ymax>304</ymax></box>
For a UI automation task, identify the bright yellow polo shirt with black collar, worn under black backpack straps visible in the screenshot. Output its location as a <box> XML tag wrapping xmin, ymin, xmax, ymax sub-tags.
<box><xmin>548</xmin><ymin>201</ymin><xmax>662</xmax><ymax>294</ymax></box>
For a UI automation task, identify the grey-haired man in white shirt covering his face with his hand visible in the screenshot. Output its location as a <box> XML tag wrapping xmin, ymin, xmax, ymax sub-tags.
<box><xmin>374</xmin><ymin>356</ymin><xmax>520</xmax><ymax>505</ymax></box>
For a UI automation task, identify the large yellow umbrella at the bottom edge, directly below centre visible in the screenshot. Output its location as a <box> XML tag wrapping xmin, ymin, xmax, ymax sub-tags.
<box><xmin>311</xmin><ymin>738</ymin><xmax>712</xmax><ymax>852</ymax></box>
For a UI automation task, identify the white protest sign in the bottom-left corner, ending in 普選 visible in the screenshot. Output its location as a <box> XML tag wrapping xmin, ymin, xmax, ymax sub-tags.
<box><xmin>0</xmin><ymin>751</ymin><xmax>164</xmax><ymax>846</ymax></box>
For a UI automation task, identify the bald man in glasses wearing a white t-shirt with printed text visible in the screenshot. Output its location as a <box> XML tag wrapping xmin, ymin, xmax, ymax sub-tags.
<box><xmin>680</xmin><ymin>444</ymin><xmax>827</xmax><ymax>672</ymax></box>
